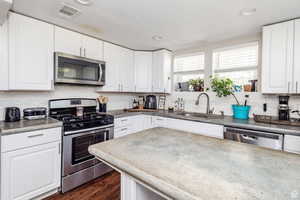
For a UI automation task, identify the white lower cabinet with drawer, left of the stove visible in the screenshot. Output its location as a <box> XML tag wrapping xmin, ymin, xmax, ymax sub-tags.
<box><xmin>1</xmin><ymin>128</ymin><xmax>61</xmax><ymax>200</ymax></box>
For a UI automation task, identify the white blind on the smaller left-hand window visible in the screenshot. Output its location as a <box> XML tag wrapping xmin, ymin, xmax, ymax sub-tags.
<box><xmin>174</xmin><ymin>54</ymin><xmax>204</xmax><ymax>72</ymax></box>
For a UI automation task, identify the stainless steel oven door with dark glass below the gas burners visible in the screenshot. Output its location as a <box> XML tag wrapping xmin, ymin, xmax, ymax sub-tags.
<box><xmin>63</xmin><ymin>128</ymin><xmax>112</xmax><ymax>176</ymax></box>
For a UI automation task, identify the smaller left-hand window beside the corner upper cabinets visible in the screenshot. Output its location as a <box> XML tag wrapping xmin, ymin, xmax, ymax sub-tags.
<box><xmin>174</xmin><ymin>53</ymin><xmax>205</xmax><ymax>88</ymax></box>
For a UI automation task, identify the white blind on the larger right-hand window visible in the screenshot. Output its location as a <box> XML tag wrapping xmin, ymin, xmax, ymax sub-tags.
<box><xmin>213</xmin><ymin>42</ymin><xmax>258</xmax><ymax>70</ymax></box>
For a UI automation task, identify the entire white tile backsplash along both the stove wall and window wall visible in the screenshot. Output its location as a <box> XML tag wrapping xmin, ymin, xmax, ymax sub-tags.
<box><xmin>0</xmin><ymin>85</ymin><xmax>300</xmax><ymax>120</ymax></box>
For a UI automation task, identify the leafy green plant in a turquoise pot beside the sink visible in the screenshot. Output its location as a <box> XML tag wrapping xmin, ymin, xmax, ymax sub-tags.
<box><xmin>211</xmin><ymin>77</ymin><xmax>251</xmax><ymax>119</ymax></box>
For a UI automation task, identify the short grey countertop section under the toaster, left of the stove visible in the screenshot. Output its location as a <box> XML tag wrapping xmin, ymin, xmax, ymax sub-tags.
<box><xmin>0</xmin><ymin>118</ymin><xmax>62</xmax><ymax>136</ymax></box>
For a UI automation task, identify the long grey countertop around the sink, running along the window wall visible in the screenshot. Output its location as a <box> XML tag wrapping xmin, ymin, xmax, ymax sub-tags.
<box><xmin>108</xmin><ymin>110</ymin><xmax>300</xmax><ymax>136</ymax></box>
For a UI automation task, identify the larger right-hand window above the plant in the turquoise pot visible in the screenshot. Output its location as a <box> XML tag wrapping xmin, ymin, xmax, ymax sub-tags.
<box><xmin>213</xmin><ymin>42</ymin><xmax>258</xmax><ymax>85</ymax></box>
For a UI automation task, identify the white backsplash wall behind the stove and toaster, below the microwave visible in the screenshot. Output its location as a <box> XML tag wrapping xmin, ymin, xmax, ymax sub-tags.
<box><xmin>0</xmin><ymin>85</ymin><xmax>133</xmax><ymax>120</ymax></box>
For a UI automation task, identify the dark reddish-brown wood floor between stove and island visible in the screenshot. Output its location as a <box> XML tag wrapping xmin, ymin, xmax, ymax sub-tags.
<box><xmin>44</xmin><ymin>171</ymin><xmax>120</xmax><ymax>200</ymax></box>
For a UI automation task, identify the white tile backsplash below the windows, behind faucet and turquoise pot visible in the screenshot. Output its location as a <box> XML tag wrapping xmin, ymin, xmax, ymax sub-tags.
<box><xmin>166</xmin><ymin>92</ymin><xmax>300</xmax><ymax>118</ymax></box>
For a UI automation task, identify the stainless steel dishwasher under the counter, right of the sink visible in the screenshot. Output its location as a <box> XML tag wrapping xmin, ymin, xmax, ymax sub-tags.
<box><xmin>224</xmin><ymin>127</ymin><xmax>283</xmax><ymax>150</ymax></box>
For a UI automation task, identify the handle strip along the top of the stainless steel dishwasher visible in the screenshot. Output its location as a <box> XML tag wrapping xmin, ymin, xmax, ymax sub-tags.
<box><xmin>225</xmin><ymin>127</ymin><xmax>283</xmax><ymax>140</ymax></box>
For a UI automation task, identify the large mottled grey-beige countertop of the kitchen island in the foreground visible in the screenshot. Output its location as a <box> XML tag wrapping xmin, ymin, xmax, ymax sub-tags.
<box><xmin>89</xmin><ymin>128</ymin><xmax>300</xmax><ymax>200</ymax></box>
